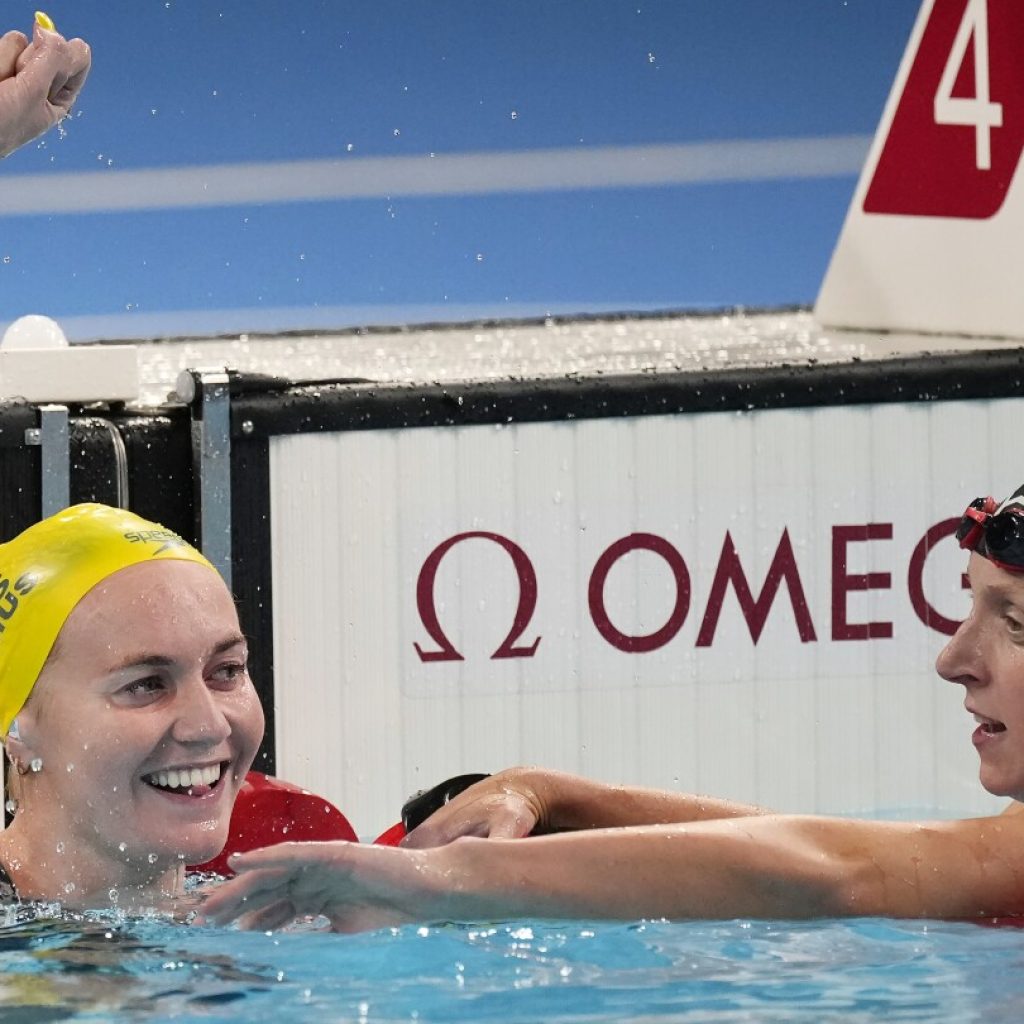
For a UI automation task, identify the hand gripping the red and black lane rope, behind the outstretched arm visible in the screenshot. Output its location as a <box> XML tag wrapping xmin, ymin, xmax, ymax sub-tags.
<box><xmin>401</xmin><ymin>768</ymin><xmax>546</xmax><ymax>850</ymax></box>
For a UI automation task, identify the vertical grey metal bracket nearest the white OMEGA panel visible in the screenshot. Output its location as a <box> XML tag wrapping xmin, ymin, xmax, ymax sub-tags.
<box><xmin>175</xmin><ymin>367</ymin><xmax>231</xmax><ymax>588</ymax></box>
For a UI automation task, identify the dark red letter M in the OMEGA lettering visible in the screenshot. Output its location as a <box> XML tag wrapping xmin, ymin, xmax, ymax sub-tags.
<box><xmin>696</xmin><ymin>529</ymin><xmax>817</xmax><ymax>647</ymax></box>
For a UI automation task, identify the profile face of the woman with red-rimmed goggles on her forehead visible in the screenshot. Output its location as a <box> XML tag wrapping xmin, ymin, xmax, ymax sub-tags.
<box><xmin>935</xmin><ymin>554</ymin><xmax>1024</xmax><ymax>800</ymax></box>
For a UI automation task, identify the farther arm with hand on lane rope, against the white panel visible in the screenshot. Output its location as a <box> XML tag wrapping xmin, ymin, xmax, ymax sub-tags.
<box><xmin>402</xmin><ymin>768</ymin><xmax>767</xmax><ymax>849</ymax></box>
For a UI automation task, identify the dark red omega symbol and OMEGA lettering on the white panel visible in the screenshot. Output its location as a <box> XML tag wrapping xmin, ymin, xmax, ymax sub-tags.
<box><xmin>414</xmin><ymin>518</ymin><xmax>967</xmax><ymax>662</ymax></box>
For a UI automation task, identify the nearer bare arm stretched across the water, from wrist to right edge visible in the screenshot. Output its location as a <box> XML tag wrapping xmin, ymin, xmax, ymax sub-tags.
<box><xmin>437</xmin><ymin>815</ymin><xmax>1024</xmax><ymax>919</ymax></box>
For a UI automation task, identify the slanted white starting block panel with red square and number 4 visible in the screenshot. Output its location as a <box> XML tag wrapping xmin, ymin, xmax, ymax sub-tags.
<box><xmin>816</xmin><ymin>0</ymin><xmax>1024</xmax><ymax>337</ymax></box>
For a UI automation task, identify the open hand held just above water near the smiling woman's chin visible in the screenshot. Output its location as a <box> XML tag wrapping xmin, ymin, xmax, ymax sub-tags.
<box><xmin>196</xmin><ymin>842</ymin><xmax>451</xmax><ymax>932</ymax></box>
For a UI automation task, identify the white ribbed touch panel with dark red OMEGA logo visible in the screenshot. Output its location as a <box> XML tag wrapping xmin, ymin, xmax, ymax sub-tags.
<box><xmin>270</xmin><ymin>399</ymin><xmax>1011</xmax><ymax>836</ymax></box>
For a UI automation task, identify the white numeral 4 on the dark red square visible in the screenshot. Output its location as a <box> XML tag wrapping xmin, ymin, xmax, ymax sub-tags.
<box><xmin>935</xmin><ymin>0</ymin><xmax>1002</xmax><ymax>171</ymax></box>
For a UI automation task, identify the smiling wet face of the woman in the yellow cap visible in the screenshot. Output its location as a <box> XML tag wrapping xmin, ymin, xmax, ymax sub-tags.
<box><xmin>13</xmin><ymin>560</ymin><xmax>263</xmax><ymax>874</ymax></box>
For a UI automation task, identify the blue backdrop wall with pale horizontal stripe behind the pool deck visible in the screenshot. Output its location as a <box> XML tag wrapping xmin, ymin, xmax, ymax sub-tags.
<box><xmin>0</xmin><ymin>0</ymin><xmax>919</xmax><ymax>338</ymax></box>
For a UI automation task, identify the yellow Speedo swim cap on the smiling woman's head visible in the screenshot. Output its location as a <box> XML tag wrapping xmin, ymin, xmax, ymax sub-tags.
<box><xmin>0</xmin><ymin>505</ymin><xmax>216</xmax><ymax>736</ymax></box>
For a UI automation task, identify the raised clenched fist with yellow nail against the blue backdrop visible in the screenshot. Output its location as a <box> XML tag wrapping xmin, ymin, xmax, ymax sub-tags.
<box><xmin>0</xmin><ymin>25</ymin><xmax>92</xmax><ymax>157</ymax></box>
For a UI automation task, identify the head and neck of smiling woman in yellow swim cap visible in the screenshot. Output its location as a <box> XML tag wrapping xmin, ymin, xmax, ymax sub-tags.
<box><xmin>0</xmin><ymin>504</ymin><xmax>263</xmax><ymax>907</ymax></box>
